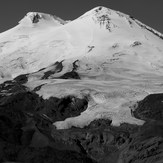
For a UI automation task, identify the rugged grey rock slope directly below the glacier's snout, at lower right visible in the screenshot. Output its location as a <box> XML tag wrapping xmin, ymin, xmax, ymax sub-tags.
<box><xmin>52</xmin><ymin>120</ymin><xmax>163</xmax><ymax>163</ymax></box>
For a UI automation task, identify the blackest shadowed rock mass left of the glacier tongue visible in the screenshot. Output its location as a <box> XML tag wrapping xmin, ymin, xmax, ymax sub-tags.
<box><xmin>0</xmin><ymin>80</ymin><xmax>91</xmax><ymax>163</ymax></box>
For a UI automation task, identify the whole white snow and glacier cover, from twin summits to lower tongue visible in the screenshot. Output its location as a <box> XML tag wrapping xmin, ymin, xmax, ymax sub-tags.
<box><xmin>0</xmin><ymin>7</ymin><xmax>163</xmax><ymax>129</ymax></box>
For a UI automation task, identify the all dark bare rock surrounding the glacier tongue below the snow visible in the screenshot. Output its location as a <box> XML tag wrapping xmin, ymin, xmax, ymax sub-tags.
<box><xmin>0</xmin><ymin>78</ymin><xmax>163</xmax><ymax>163</ymax></box>
